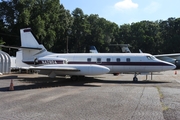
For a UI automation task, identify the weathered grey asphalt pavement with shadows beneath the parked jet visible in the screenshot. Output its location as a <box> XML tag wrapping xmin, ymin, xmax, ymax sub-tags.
<box><xmin>0</xmin><ymin>71</ymin><xmax>180</xmax><ymax>120</ymax></box>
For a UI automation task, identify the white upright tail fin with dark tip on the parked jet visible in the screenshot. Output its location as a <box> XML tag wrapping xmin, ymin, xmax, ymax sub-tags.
<box><xmin>20</xmin><ymin>28</ymin><xmax>49</xmax><ymax>61</ymax></box>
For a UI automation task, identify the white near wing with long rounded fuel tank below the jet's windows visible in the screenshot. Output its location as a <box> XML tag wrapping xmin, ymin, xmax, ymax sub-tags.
<box><xmin>38</xmin><ymin>64</ymin><xmax>110</xmax><ymax>76</ymax></box>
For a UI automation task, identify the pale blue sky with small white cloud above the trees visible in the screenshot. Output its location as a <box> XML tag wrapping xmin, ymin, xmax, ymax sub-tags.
<box><xmin>60</xmin><ymin>0</ymin><xmax>180</xmax><ymax>25</ymax></box>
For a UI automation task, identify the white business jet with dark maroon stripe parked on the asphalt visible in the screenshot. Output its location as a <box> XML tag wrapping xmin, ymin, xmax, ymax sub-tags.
<box><xmin>1</xmin><ymin>28</ymin><xmax>176</xmax><ymax>82</ymax></box>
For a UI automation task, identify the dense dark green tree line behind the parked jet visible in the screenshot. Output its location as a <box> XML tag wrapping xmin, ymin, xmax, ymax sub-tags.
<box><xmin>0</xmin><ymin>0</ymin><xmax>180</xmax><ymax>54</ymax></box>
